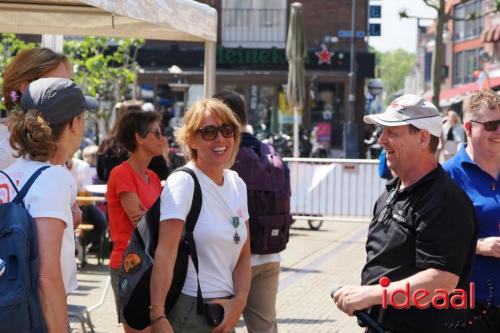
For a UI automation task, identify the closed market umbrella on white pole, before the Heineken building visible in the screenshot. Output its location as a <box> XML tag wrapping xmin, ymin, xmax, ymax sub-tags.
<box><xmin>286</xmin><ymin>2</ymin><xmax>306</xmax><ymax>157</ymax></box>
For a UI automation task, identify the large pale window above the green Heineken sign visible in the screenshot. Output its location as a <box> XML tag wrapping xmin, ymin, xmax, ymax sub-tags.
<box><xmin>221</xmin><ymin>0</ymin><xmax>287</xmax><ymax>48</ymax></box>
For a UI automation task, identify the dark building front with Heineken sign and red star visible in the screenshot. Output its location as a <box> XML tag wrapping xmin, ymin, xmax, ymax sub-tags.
<box><xmin>138</xmin><ymin>0</ymin><xmax>375</xmax><ymax>150</ymax></box>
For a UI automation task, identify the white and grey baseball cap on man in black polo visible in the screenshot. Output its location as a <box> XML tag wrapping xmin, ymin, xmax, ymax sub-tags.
<box><xmin>363</xmin><ymin>94</ymin><xmax>443</xmax><ymax>138</ymax></box>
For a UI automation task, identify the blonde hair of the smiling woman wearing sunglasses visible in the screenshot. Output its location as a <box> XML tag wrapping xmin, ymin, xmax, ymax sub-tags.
<box><xmin>175</xmin><ymin>98</ymin><xmax>241</xmax><ymax>168</ymax></box>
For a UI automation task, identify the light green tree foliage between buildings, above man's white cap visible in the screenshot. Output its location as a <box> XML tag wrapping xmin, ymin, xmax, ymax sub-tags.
<box><xmin>375</xmin><ymin>49</ymin><xmax>415</xmax><ymax>102</ymax></box>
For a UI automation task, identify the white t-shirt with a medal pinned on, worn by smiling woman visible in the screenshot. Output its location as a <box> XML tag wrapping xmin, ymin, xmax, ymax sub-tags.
<box><xmin>160</xmin><ymin>163</ymin><xmax>248</xmax><ymax>298</ymax></box>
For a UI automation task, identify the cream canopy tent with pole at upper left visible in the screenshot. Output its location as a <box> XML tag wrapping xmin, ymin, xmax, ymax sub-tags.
<box><xmin>0</xmin><ymin>0</ymin><xmax>217</xmax><ymax>96</ymax></box>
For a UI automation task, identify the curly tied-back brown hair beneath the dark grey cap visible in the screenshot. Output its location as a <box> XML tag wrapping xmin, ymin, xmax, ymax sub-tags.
<box><xmin>8</xmin><ymin>110</ymin><xmax>73</xmax><ymax>162</ymax></box>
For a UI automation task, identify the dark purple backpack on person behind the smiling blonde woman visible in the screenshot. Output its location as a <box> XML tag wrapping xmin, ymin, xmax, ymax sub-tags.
<box><xmin>232</xmin><ymin>143</ymin><xmax>292</xmax><ymax>254</ymax></box>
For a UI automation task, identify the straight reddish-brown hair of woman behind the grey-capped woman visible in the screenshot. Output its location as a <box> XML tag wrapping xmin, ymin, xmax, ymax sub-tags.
<box><xmin>2</xmin><ymin>47</ymin><xmax>72</xmax><ymax>110</ymax></box>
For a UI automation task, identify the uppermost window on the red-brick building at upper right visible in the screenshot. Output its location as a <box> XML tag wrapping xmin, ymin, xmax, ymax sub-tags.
<box><xmin>453</xmin><ymin>0</ymin><xmax>485</xmax><ymax>41</ymax></box>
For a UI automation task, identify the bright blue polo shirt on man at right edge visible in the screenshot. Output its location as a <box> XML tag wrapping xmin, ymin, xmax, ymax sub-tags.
<box><xmin>443</xmin><ymin>145</ymin><xmax>500</xmax><ymax>306</ymax></box>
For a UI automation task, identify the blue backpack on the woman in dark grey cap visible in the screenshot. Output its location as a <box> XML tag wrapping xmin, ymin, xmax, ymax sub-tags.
<box><xmin>0</xmin><ymin>166</ymin><xmax>49</xmax><ymax>333</ymax></box>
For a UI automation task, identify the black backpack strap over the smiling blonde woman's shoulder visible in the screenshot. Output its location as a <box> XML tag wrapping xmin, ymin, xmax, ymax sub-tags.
<box><xmin>176</xmin><ymin>167</ymin><xmax>203</xmax><ymax>315</ymax></box>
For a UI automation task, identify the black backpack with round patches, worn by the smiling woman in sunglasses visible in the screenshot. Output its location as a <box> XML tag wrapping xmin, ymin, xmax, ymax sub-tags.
<box><xmin>118</xmin><ymin>167</ymin><xmax>203</xmax><ymax>330</ymax></box>
